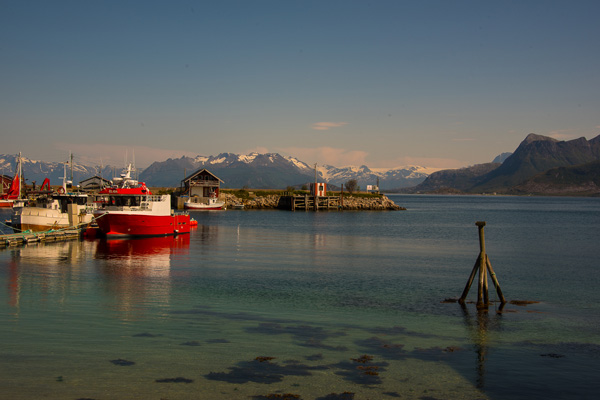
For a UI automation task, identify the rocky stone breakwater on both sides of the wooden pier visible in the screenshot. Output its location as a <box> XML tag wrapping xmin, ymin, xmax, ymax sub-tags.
<box><xmin>221</xmin><ymin>193</ymin><xmax>406</xmax><ymax>210</ymax></box>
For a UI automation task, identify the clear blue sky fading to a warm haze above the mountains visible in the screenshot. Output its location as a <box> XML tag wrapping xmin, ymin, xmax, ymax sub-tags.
<box><xmin>0</xmin><ymin>0</ymin><xmax>600</xmax><ymax>168</ymax></box>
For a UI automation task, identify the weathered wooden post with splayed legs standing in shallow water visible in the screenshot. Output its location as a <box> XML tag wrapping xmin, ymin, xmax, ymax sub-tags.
<box><xmin>458</xmin><ymin>221</ymin><xmax>506</xmax><ymax>308</ymax></box>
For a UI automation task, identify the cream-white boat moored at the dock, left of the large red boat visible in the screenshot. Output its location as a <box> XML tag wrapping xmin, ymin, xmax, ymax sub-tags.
<box><xmin>11</xmin><ymin>162</ymin><xmax>93</xmax><ymax>233</ymax></box>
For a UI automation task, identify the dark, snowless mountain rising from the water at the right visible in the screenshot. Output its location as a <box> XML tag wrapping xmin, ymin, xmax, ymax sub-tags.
<box><xmin>405</xmin><ymin>133</ymin><xmax>600</xmax><ymax>195</ymax></box>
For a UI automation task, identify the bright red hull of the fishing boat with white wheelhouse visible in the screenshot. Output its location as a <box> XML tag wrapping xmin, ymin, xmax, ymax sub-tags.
<box><xmin>96</xmin><ymin>213</ymin><xmax>190</xmax><ymax>236</ymax></box>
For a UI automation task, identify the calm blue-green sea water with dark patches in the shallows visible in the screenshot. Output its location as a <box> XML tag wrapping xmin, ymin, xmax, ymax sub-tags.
<box><xmin>0</xmin><ymin>196</ymin><xmax>600</xmax><ymax>400</ymax></box>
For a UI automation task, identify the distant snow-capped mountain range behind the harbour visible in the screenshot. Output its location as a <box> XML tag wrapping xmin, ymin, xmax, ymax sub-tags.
<box><xmin>0</xmin><ymin>153</ymin><xmax>432</xmax><ymax>190</ymax></box>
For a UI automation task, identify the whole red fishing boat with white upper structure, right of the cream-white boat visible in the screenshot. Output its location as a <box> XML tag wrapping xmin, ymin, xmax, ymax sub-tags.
<box><xmin>94</xmin><ymin>164</ymin><xmax>190</xmax><ymax>236</ymax></box>
